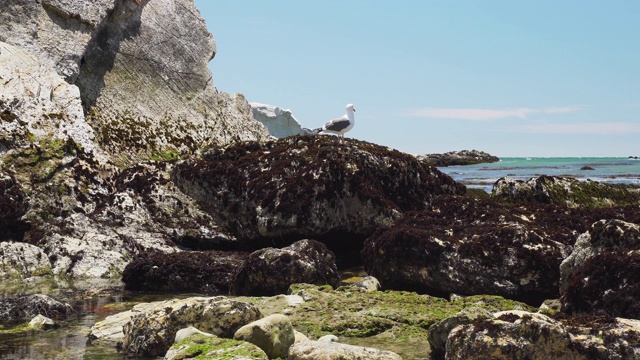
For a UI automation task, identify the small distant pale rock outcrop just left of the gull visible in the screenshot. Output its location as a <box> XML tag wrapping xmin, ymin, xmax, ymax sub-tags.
<box><xmin>250</xmin><ymin>102</ymin><xmax>306</xmax><ymax>138</ymax></box>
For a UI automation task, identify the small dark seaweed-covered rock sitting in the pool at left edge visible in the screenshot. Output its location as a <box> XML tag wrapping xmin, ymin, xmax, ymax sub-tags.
<box><xmin>0</xmin><ymin>294</ymin><xmax>75</xmax><ymax>323</ymax></box>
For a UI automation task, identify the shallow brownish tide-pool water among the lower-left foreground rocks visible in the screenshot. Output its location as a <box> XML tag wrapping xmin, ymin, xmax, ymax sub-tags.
<box><xmin>0</xmin><ymin>267</ymin><xmax>372</xmax><ymax>360</ymax></box>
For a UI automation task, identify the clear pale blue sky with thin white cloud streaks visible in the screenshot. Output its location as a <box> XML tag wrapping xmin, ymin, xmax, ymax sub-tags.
<box><xmin>195</xmin><ymin>0</ymin><xmax>640</xmax><ymax>157</ymax></box>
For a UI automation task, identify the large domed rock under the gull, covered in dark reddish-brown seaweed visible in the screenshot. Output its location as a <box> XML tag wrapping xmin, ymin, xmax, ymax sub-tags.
<box><xmin>174</xmin><ymin>136</ymin><xmax>465</xmax><ymax>248</ymax></box>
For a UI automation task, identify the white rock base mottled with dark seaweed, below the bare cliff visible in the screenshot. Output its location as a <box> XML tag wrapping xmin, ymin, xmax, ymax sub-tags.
<box><xmin>4</xmin><ymin>149</ymin><xmax>235</xmax><ymax>277</ymax></box>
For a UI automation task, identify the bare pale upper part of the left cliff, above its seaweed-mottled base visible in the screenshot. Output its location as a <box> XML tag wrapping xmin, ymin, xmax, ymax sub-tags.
<box><xmin>0</xmin><ymin>0</ymin><xmax>267</xmax><ymax>161</ymax></box>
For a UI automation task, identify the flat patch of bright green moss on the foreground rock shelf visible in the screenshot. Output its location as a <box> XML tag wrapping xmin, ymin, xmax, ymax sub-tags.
<box><xmin>239</xmin><ymin>284</ymin><xmax>535</xmax><ymax>341</ymax></box>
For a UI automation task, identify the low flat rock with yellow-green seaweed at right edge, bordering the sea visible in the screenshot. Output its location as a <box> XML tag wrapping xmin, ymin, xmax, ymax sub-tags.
<box><xmin>492</xmin><ymin>176</ymin><xmax>640</xmax><ymax>208</ymax></box>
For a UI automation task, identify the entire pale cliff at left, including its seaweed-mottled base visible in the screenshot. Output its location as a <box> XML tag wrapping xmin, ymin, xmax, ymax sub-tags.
<box><xmin>0</xmin><ymin>0</ymin><xmax>268</xmax><ymax>277</ymax></box>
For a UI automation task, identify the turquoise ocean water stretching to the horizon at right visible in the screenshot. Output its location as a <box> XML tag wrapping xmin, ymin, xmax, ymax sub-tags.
<box><xmin>438</xmin><ymin>157</ymin><xmax>640</xmax><ymax>193</ymax></box>
